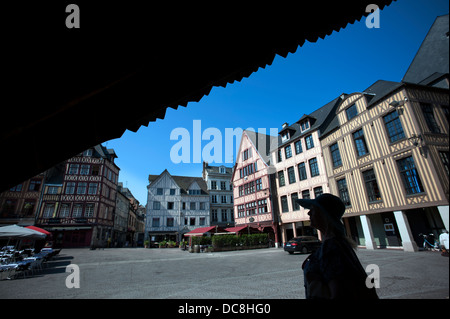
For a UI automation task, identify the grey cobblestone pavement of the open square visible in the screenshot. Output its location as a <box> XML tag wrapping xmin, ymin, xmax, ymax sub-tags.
<box><xmin>0</xmin><ymin>248</ymin><xmax>449</xmax><ymax>299</ymax></box>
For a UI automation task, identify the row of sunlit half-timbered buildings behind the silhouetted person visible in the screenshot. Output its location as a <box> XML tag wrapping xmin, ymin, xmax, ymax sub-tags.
<box><xmin>233</xmin><ymin>15</ymin><xmax>449</xmax><ymax>251</ymax></box>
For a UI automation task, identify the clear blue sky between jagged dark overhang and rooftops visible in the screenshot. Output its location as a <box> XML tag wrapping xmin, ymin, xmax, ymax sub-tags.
<box><xmin>103</xmin><ymin>0</ymin><xmax>449</xmax><ymax>205</ymax></box>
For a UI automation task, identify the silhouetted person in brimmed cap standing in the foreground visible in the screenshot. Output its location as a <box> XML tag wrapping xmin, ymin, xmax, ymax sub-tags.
<box><xmin>297</xmin><ymin>194</ymin><xmax>378</xmax><ymax>299</ymax></box>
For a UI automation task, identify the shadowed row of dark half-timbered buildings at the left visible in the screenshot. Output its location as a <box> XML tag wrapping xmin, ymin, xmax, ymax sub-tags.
<box><xmin>0</xmin><ymin>145</ymin><xmax>144</xmax><ymax>247</ymax></box>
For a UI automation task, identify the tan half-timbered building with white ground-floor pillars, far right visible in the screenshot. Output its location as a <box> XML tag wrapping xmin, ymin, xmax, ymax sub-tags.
<box><xmin>321</xmin><ymin>81</ymin><xmax>449</xmax><ymax>251</ymax></box>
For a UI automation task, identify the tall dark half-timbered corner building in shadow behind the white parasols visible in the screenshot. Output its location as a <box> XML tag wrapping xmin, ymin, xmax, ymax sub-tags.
<box><xmin>36</xmin><ymin>145</ymin><xmax>119</xmax><ymax>247</ymax></box>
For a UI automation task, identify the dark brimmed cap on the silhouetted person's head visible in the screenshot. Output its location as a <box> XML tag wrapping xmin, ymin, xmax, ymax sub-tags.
<box><xmin>297</xmin><ymin>193</ymin><xmax>345</xmax><ymax>232</ymax></box>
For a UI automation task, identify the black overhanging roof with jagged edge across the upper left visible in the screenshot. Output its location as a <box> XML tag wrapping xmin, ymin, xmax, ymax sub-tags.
<box><xmin>0</xmin><ymin>0</ymin><xmax>392</xmax><ymax>191</ymax></box>
